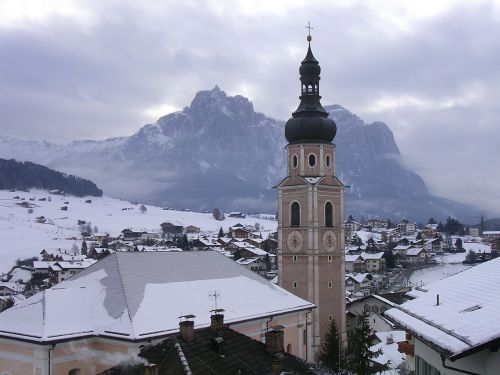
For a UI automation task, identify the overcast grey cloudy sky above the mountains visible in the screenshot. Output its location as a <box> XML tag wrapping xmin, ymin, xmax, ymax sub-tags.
<box><xmin>0</xmin><ymin>0</ymin><xmax>500</xmax><ymax>213</ymax></box>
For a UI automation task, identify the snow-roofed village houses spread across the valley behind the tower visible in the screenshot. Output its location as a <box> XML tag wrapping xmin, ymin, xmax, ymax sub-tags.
<box><xmin>0</xmin><ymin>192</ymin><xmax>500</xmax><ymax>310</ymax></box>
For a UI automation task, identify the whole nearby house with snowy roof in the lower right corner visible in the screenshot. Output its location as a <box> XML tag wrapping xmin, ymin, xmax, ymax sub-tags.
<box><xmin>385</xmin><ymin>259</ymin><xmax>500</xmax><ymax>375</ymax></box>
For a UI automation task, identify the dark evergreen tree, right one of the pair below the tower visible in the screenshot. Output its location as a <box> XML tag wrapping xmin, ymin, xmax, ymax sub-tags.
<box><xmin>349</xmin><ymin>311</ymin><xmax>387</xmax><ymax>375</ymax></box>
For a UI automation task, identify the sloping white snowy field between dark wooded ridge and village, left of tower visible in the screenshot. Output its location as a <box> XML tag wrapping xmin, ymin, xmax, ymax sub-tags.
<box><xmin>0</xmin><ymin>190</ymin><xmax>278</xmax><ymax>274</ymax></box>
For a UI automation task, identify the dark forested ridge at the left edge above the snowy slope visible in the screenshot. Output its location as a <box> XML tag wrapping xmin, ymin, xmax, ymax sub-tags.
<box><xmin>0</xmin><ymin>159</ymin><xmax>102</xmax><ymax>197</ymax></box>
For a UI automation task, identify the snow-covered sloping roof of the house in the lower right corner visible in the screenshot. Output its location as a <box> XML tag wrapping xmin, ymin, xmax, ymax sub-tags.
<box><xmin>385</xmin><ymin>258</ymin><xmax>500</xmax><ymax>356</ymax></box>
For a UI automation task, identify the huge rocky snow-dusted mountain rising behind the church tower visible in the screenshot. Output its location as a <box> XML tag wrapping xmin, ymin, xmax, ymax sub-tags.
<box><xmin>0</xmin><ymin>86</ymin><xmax>478</xmax><ymax>221</ymax></box>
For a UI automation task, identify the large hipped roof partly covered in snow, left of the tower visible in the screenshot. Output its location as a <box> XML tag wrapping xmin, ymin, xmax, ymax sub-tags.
<box><xmin>0</xmin><ymin>251</ymin><xmax>314</xmax><ymax>342</ymax></box>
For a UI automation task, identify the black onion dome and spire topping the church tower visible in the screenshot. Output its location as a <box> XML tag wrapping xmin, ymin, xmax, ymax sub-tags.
<box><xmin>285</xmin><ymin>36</ymin><xmax>337</xmax><ymax>143</ymax></box>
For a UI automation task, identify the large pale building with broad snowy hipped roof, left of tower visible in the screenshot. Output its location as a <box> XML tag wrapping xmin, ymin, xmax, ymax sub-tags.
<box><xmin>0</xmin><ymin>251</ymin><xmax>315</xmax><ymax>375</ymax></box>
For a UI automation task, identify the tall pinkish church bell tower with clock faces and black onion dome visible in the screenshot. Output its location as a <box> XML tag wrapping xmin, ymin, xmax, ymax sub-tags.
<box><xmin>277</xmin><ymin>36</ymin><xmax>346</xmax><ymax>358</ymax></box>
